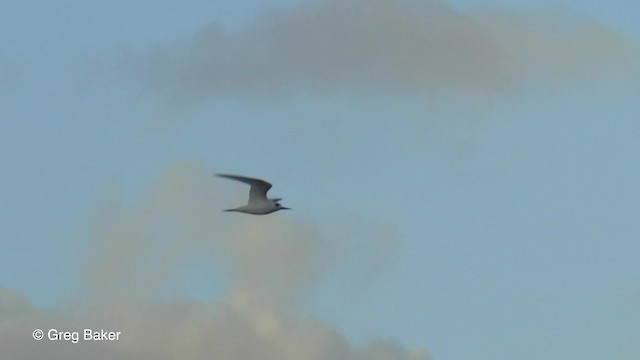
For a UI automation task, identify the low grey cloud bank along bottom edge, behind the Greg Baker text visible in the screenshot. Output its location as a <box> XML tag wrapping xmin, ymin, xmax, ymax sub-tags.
<box><xmin>0</xmin><ymin>302</ymin><xmax>428</xmax><ymax>360</ymax></box>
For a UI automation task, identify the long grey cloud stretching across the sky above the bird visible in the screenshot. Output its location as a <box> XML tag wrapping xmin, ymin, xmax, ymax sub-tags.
<box><xmin>123</xmin><ymin>0</ymin><xmax>640</xmax><ymax>106</ymax></box>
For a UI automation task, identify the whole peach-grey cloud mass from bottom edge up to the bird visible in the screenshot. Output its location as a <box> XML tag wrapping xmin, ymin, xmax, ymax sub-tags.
<box><xmin>0</xmin><ymin>162</ymin><xmax>428</xmax><ymax>360</ymax></box>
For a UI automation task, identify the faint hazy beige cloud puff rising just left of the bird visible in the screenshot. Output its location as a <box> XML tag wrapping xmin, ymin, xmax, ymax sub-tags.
<box><xmin>83</xmin><ymin>163</ymin><xmax>230</xmax><ymax>302</ymax></box>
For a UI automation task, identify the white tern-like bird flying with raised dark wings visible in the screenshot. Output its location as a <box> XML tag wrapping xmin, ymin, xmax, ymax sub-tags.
<box><xmin>216</xmin><ymin>174</ymin><xmax>291</xmax><ymax>215</ymax></box>
